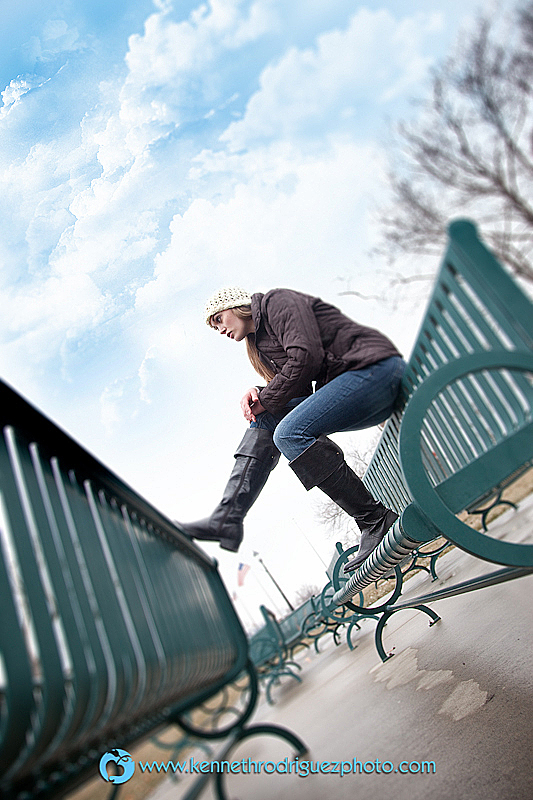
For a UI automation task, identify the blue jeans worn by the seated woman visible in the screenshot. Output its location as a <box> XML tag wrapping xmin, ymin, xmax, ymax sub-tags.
<box><xmin>250</xmin><ymin>356</ymin><xmax>405</xmax><ymax>461</ymax></box>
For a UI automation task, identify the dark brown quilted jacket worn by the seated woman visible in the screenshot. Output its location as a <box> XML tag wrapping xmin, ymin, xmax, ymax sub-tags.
<box><xmin>252</xmin><ymin>289</ymin><xmax>400</xmax><ymax>411</ymax></box>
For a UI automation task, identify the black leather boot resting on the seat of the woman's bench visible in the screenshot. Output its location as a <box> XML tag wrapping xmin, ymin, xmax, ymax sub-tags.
<box><xmin>289</xmin><ymin>436</ymin><xmax>398</xmax><ymax>572</ymax></box>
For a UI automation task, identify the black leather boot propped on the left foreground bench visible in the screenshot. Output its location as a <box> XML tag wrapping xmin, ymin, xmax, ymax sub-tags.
<box><xmin>178</xmin><ymin>428</ymin><xmax>280</xmax><ymax>553</ymax></box>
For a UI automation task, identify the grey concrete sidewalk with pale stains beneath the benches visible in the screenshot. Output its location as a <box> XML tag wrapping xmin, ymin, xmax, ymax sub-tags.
<box><xmin>149</xmin><ymin>496</ymin><xmax>533</xmax><ymax>800</ymax></box>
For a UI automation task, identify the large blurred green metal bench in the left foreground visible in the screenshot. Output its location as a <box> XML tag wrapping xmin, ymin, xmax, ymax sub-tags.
<box><xmin>0</xmin><ymin>383</ymin><xmax>305</xmax><ymax>800</ymax></box>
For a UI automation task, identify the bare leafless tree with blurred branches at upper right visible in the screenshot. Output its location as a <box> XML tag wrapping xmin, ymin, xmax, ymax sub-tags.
<box><xmin>379</xmin><ymin>0</ymin><xmax>533</xmax><ymax>281</ymax></box>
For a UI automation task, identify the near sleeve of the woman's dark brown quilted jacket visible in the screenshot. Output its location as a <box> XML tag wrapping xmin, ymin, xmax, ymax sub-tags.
<box><xmin>259</xmin><ymin>289</ymin><xmax>324</xmax><ymax>411</ymax></box>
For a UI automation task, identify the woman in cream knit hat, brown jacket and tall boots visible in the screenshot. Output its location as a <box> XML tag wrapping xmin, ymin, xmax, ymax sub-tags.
<box><xmin>182</xmin><ymin>288</ymin><xmax>405</xmax><ymax>572</ymax></box>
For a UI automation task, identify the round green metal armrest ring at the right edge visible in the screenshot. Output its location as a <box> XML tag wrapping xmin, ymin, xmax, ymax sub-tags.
<box><xmin>399</xmin><ymin>350</ymin><xmax>533</xmax><ymax>567</ymax></box>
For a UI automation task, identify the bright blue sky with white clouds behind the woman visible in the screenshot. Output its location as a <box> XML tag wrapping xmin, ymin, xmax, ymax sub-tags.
<box><xmin>0</xmin><ymin>0</ymin><xmax>509</xmax><ymax>625</ymax></box>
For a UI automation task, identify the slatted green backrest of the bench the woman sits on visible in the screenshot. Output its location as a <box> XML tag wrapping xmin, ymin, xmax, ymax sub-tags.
<box><xmin>363</xmin><ymin>220</ymin><xmax>533</xmax><ymax>512</ymax></box>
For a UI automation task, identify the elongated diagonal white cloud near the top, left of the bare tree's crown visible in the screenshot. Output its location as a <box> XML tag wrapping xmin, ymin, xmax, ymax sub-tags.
<box><xmin>221</xmin><ymin>8</ymin><xmax>441</xmax><ymax>150</ymax></box>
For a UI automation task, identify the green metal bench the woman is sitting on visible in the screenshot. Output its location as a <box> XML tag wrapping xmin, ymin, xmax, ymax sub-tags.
<box><xmin>331</xmin><ymin>220</ymin><xmax>533</xmax><ymax>660</ymax></box>
